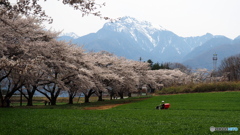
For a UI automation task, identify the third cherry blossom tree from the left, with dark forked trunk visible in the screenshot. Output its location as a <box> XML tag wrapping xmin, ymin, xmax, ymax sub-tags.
<box><xmin>35</xmin><ymin>40</ymin><xmax>91</xmax><ymax>105</ymax></box>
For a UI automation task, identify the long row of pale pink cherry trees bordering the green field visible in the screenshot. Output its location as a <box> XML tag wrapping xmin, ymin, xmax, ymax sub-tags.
<box><xmin>0</xmin><ymin>10</ymin><xmax>219</xmax><ymax>106</ymax></box>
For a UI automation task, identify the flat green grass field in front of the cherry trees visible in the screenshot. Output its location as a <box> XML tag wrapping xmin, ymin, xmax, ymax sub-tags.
<box><xmin>0</xmin><ymin>92</ymin><xmax>240</xmax><ymax>135</ymax></box>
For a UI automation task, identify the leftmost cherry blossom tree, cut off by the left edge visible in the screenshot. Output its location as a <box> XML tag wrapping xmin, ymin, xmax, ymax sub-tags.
<box><xmin>0</xmin><ymin>11</ymin><xmax>58</xmax><ymax>106</ymax></box>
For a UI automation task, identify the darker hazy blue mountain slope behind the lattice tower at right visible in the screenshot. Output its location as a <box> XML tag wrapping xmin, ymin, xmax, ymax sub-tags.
<box><xmin>183</xmin><ymin>36</ymin><xmax>240</xmax><ymax>70</ymax></box>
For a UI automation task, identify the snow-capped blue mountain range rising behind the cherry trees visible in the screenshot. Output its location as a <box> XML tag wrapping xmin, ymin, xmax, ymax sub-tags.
<box><xmin>59</xmin><ymin>17</ymin><xmax>240</xmax><ymax>68</ymax></box>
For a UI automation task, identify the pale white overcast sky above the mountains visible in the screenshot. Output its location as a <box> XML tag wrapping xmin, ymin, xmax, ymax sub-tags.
<box><xmin>38</xmin><ymin>0</ymin><xmax>240</xmax><ymax>39</ymax></box>
